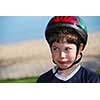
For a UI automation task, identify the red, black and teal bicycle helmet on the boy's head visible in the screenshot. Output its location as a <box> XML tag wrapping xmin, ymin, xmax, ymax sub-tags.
<box><xmin>45</xmin><ymin>16</ymin><xmax>88</xmax><ymax>49</ymax></box>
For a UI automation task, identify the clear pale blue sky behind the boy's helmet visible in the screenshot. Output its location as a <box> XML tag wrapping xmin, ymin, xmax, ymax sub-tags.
<box><xmin>0</xmin><ymin>16</ymin><xmax>100</xmax><ymax>43</ymax></box>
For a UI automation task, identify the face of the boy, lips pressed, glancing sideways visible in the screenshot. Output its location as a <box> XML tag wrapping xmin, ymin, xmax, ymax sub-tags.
<box><xmin>51</xmin><ymin>42</ymin><xmax>77</xmax><ymax>69</ymax></box>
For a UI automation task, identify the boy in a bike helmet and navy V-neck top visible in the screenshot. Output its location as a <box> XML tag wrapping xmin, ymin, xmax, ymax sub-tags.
<box><xmin>37</xmin><ymin>16</ymin><xmax>100</xmax><ymax>83</ymax></box>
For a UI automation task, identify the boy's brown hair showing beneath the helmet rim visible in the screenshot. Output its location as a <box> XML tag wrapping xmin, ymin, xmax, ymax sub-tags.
<box><xmin>46</xmin><ymin>28</ymin><xmax>82</xmax><ymax>49</ymax></box>
